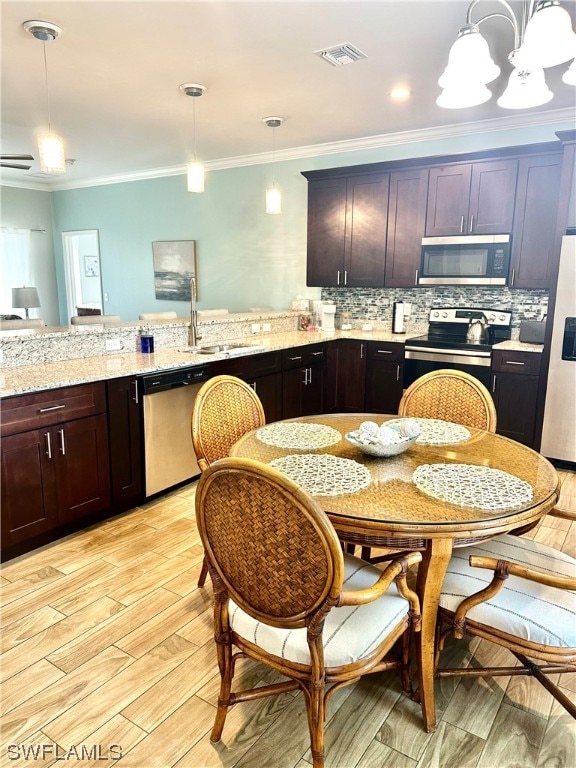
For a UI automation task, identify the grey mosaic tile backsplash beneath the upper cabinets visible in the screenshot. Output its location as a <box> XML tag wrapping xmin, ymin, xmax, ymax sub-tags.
<box><xmin>322</xmin><ymin>286</ymin><xmax>548</xmax><ymax>328</ymax></box>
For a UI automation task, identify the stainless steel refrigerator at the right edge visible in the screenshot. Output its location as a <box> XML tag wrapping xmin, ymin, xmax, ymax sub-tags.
<box><xmin>540</xmin><ymin>234</ymin><xmax>576</xmax><ymax>462</ymax></box>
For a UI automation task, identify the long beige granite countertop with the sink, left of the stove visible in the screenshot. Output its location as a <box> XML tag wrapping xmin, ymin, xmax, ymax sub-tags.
<box><xmin>0</xmin><ymin>330</ymin><xmax>421</xmax><ymax>397</ymax></box>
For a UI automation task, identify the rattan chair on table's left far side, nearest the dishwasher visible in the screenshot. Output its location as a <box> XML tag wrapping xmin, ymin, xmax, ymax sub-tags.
<box><xmin>191</xmin><ymin>376</ymin><xmax>266</xmax><ymax>587</ymax></box>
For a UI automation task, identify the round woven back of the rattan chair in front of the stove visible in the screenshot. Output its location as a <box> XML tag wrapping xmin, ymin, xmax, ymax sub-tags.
<box><xmin>398</xmin><ymin>368</ymin><xmax>496</xmax><ymax>432</ymax></box>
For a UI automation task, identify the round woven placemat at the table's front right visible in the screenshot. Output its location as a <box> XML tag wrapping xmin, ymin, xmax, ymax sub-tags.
<box><xmin>412</xmin><ymin>464</ymin><xmax>534</xmax><ymax>510</ymax></box>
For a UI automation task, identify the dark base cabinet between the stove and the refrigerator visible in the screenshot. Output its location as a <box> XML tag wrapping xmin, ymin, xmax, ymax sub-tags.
<box><xmin>491</xmin><ymin>350</ymin><xmax>542</xmax><ymax>448</ymax></box>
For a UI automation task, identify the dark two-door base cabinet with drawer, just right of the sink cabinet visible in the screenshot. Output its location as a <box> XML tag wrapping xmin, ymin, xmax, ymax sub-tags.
<box><xmin>282</xmin><ymin>343</ymin><xmax>327</xmax><ymax>419</ymax></box>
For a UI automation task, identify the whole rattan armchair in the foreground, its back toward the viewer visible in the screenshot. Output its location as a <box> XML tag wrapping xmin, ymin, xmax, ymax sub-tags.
<box><xmin>196</xmin><ymin>458</ymin><xmax>421</xmax><ymax>768</ymax></box>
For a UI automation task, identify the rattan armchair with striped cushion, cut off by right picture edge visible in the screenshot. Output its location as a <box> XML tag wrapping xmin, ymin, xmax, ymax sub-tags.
<box><xmin>436</xmin><ymin>510</ymin><xmax>576</xmax><ymax>718</ymax></box>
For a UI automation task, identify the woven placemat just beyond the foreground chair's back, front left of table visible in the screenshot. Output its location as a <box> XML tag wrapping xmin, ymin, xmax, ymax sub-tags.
<box><xmin>270</xmin><ymin>453</ymin><xmax>371</xmax><ymax>496</ymax></box>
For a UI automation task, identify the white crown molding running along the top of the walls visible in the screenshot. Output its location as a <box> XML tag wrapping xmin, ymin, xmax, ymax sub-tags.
<box><xmin>1</xmin><ymin>108</ymin><xmax>575</xmax><ymax>192</ymax></box>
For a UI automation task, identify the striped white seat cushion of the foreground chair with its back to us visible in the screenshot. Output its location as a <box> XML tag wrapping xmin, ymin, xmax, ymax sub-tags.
<box><xmin>229</xmin><ymin>555</ymin><xmax>409</xmax><ymax>667</ymax></box>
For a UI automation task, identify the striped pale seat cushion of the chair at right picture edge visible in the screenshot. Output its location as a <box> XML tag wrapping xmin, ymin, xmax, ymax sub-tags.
<box><xmin>440</xmin><ymin>536</ymin><xmax>576</xmax><ymax>648</ymax></box>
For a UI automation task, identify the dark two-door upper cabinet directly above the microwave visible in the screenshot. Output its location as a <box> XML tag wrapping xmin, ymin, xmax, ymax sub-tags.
<box><xmin>426</xmin><ymin>160</ymin><xmax>518</xmax><ymax>237</ymax></box>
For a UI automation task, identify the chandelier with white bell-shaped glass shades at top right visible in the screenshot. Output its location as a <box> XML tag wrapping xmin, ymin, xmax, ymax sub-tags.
<box><xmin>436</xmin><ymin>0</ymin><xmax>576</xmax><ymax>109</ymax></box>
